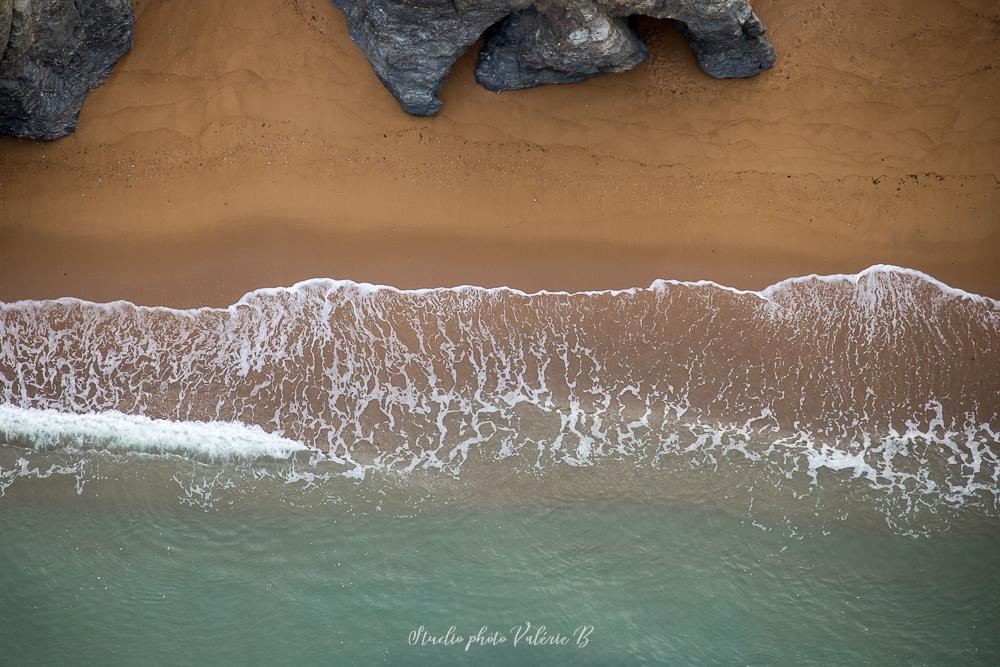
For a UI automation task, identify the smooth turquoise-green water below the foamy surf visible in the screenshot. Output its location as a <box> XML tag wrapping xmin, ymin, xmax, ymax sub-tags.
<box><xmin>0</xmin><ymin>464</ymin><xmax>1000</xmax><ymax>665</ymax></box>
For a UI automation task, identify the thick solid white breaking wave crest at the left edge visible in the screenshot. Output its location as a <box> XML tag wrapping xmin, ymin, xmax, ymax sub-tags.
<box><xmin>0</xmin><ymin>405</ymin><xmax>307</xmax><ymax>461</ymax></box>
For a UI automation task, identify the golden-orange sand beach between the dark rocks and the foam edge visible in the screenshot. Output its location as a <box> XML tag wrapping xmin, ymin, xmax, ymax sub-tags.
<box><xmin>0</xmin><ymin>0</ymin><xmax>1000</xmax><ymax>306</ymax></box>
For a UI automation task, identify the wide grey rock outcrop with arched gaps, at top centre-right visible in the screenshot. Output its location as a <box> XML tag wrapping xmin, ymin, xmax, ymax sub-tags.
<box><xmin>333</xmin><ymin>0</ymin><xmax>775</xmax><ymax>116</ymax></box>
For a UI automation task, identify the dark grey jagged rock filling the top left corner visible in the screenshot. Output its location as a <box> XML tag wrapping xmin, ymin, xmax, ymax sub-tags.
<box><xmin>0</xmin><ymin>0</ymin><xmax>135</xmax><ymax>139</ymax></box>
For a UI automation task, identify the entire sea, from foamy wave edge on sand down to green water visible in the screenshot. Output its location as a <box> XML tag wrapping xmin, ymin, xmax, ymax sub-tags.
<box><xmin>0</xmin><ymin>267</ymin><xmax>1000</xmax><ymax>665</ymax></box>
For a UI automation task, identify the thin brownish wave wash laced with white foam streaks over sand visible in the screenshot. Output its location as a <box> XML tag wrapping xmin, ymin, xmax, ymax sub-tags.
<box><xmin>0</xmin><ymin>266</ymin><xmax>1000</xmax><ymax>532</ymax></box>
